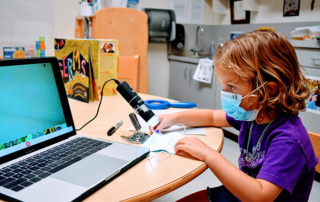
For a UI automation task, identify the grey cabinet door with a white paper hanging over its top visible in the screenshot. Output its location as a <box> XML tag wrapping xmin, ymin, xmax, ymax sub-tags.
<box><xmin>188</xmin><ymin>64</ymin><xmax>215</xmax><ymax>109</ymax></box>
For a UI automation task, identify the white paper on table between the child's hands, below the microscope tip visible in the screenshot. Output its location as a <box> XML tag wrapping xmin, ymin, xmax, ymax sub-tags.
<box><xmin>142</xmin><ymin>132</ymin><xmax>184</xmax><ymax>154</ymax></box>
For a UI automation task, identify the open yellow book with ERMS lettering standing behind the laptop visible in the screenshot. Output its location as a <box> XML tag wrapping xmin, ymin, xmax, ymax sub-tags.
<box><xmin>54</xmin><ymin>39</ymin><xmax>119</xmax><ymax>102</ymax></box>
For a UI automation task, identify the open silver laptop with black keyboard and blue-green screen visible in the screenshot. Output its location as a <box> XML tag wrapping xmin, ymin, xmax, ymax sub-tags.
<box><xmin>0</xmin><ymin>57</ymin><xmax>150</xmax><ymax>202</ymax></box>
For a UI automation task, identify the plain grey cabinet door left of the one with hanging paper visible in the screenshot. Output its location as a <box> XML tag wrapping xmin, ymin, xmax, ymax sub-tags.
<box><xmin>169</xmin><ymin>61</ymin><xmax>189</xmax><ymax>102</ymax></box>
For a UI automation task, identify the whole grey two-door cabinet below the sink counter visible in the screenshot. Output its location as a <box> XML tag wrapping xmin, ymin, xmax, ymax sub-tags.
<box><xmin>169</xmin><ymin>60</ymin><xmax>220</xmax><ymax>109</ymax></box>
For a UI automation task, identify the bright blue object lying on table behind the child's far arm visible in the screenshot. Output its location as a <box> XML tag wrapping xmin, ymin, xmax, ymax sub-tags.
<box><xmin>144</xmin><ymin>100</ymin><xmax>197</xmax><ymax>109</ymax></box>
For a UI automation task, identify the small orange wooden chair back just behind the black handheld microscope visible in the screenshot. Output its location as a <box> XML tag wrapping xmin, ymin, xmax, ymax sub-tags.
<box><xmin>118</xmin><ymin>55</ymin><xmax>139</xmax><ymax>92</ymax></box>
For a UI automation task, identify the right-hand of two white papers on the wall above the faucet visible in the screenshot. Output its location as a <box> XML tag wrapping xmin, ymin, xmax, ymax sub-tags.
<box><xmin>188</xmin><ymin>0</ymin><xmax>204</xmax><ymax>23</ymax></box>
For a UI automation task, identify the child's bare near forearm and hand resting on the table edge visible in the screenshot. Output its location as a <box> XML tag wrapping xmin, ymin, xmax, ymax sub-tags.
<box><xmin>175</xmin><ymin>137</ymin><xmax>283</xmax><ymax>202</ymax></box>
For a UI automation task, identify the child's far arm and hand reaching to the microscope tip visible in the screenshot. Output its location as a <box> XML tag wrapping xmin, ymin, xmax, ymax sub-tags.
<box><xmin>149</xmin><ymin>109</ymin><xmax>230</xmax><ymax>133</ymax></box>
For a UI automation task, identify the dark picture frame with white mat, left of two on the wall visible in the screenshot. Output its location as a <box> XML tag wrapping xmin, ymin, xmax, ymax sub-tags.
<box><xmin>230</xmin><ymin>0</ymin><xmax>250</xmax><ymax>24</ymax></box>
